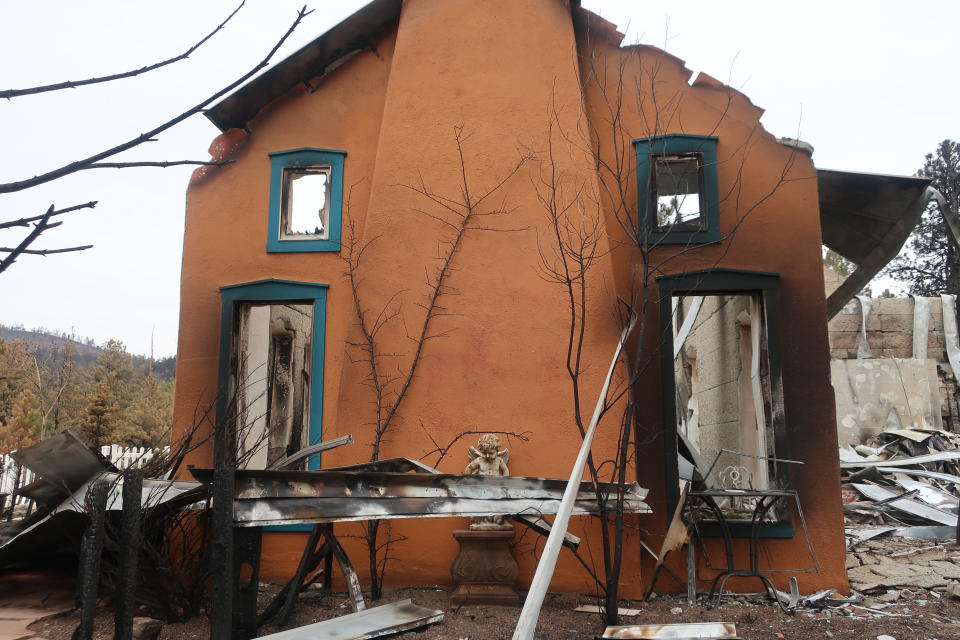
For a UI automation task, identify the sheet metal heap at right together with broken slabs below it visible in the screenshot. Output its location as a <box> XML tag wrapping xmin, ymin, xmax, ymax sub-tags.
<box><xmin>836</xmin><ymin>429</ymin><xmax>960</xmax><ymax>623</ymax></box>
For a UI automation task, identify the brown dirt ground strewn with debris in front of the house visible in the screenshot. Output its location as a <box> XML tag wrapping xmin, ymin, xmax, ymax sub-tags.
<box><xmin>20</xmin><ymin>545</ymin><xmax>960</xmax><ymax>640</ymax></box>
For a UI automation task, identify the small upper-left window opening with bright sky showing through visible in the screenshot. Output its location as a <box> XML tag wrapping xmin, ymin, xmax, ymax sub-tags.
<box><xmin>280</xmin><ymin>166</ymin><xmax>331</xmax><ymax>240</ymax></box>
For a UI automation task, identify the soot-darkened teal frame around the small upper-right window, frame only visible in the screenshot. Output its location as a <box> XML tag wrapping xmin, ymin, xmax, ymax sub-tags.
<box><xmin>633</xmin><ymin>133</ymin><xmax>720</xmax><ymax>246</ymax></box>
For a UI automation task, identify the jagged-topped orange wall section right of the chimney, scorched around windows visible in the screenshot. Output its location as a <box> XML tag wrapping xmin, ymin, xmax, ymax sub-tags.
<box><xmin>575</xmin><ymin>7</ymin><xmax>846</xmax><ymax>589</ymax></box>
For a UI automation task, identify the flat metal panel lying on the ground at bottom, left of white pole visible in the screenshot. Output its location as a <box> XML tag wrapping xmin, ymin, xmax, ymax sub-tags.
<box><xmin>261</xmin><ymin>599</ymin><xmax>443</xmax><ymax>640</ymax></box>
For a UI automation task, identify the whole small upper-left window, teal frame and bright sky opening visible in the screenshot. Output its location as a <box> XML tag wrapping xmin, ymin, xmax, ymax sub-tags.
<box><xmin>267</xmin><ymin>149</ymin><xmax>346</xmax><ymax>253</ymax></box>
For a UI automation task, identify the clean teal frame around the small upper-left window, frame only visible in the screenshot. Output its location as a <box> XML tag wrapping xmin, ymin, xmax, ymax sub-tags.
<box><xmin>267</xmin><ymin>147</ymin><xmax>347</xmax><ymax>253</ymax></box>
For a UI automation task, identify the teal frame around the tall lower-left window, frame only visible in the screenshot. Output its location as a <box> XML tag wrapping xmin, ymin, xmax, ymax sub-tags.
<box><xmin>217</xmin><ymin>278</ymin><xmax>328</xmax><ymax>471</ymax></box>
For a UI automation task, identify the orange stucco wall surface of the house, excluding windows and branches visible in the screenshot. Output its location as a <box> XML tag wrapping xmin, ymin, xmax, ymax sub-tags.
<box><xmin>175</xmin><ymin>0</ymin><xmax>845</xmax><ymax>596</ymax></box>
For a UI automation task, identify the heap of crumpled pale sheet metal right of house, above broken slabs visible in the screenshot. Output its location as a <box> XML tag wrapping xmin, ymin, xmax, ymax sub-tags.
<box><xmin>840</xmin><ymin>429</ymin><xmax>960</xmax><ymax>536</ymax></box>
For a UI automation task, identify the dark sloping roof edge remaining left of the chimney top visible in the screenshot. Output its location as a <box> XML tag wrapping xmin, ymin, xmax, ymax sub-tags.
<box><xmin>204</xmin><ymin>0</ymin><xmax>402</xmax><ymax>131</ymax></box>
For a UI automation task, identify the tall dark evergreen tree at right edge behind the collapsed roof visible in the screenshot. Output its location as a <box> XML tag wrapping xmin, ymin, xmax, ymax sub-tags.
<box><xmin>886</xmin><ymin>140</ymin><xmax>960</xmax><ymax>296</ymax></box>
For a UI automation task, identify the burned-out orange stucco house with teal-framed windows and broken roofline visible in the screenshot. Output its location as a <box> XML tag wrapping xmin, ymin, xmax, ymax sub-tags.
<box><xmin>167</xmin><ymin>0</ymin><xmax>846</xmax><ymax>596</ymax></box>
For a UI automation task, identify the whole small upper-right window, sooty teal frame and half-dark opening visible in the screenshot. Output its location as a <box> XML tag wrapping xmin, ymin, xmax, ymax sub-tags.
<box><xmin>634</xmin><ymin>134</ymin><xmax>720</xmax><ymax>244</ymax></box>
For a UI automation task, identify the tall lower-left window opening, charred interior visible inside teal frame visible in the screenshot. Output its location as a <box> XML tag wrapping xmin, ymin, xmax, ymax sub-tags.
<box><xmin>230</xmin><ymin>302</ymin><xmax>314</xmax><ymax>469</ymax></box>
